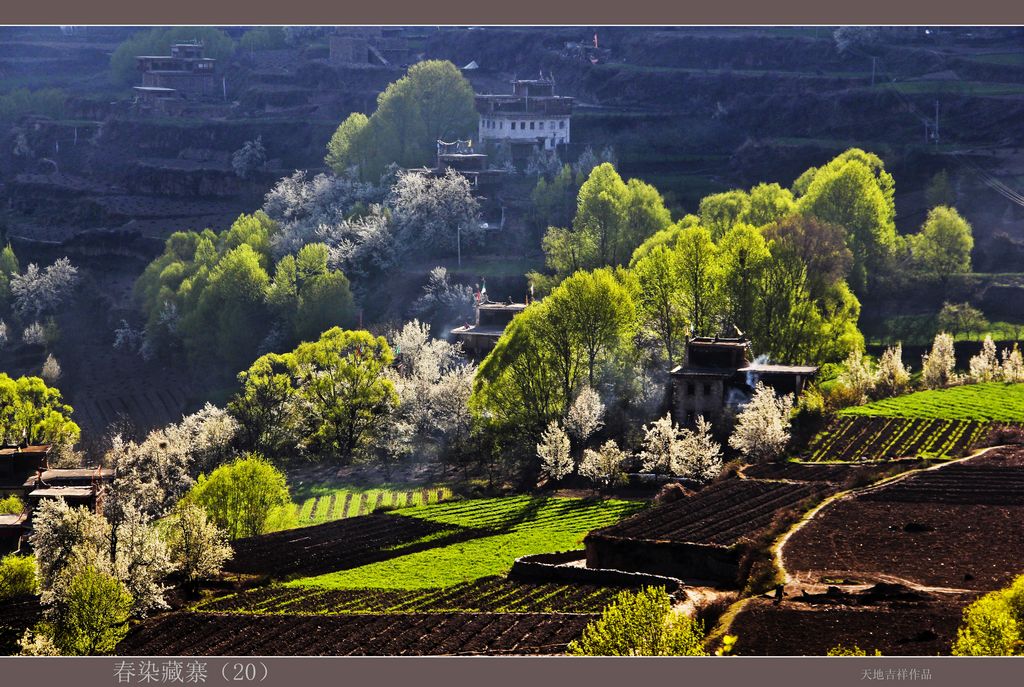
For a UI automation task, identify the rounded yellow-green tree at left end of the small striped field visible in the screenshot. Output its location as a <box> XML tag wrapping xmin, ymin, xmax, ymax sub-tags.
<box><xmin>185</xmin><ymin>454</ymin><xmax>290</xmax><ymax>540</ymax></box>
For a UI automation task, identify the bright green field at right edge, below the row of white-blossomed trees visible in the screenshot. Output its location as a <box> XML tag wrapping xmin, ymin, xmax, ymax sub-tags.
<box><xmin>840</xmin><ymin>382</ymin><xmax>1024</xmax><ymax>423</ymax></box>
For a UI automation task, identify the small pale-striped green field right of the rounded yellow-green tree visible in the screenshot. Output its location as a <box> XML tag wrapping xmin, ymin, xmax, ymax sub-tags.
<box><xmin>293</xmin><ymin>484</ymin><xmax>452</xmax><ymax>527</ymax></box>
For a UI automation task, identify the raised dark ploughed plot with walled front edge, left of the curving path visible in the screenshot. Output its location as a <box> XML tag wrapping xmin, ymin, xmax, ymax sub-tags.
<box><xmin>592</xmin><ymin>479</ymin><xmax>837</xmax><ymax>547</ymax></box>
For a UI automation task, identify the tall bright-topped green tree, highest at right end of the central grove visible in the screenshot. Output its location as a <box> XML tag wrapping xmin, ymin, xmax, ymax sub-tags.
<box><xmin>797</xmin><ymin>148</ymin><xmax>897</xmax><ymax>293</ymax></box>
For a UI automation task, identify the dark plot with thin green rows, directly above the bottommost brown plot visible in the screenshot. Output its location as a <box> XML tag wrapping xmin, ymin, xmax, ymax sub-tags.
<box><xmin>197</xmin><ymin>576</ymin><xmax>620</xmax><ymax>615</ymax></box>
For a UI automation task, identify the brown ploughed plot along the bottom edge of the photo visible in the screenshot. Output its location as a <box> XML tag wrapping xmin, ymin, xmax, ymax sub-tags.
<box><xmin>117</xmin><ymin>612</ymin><xmax>596</xmax><ymax>656</ymax></box>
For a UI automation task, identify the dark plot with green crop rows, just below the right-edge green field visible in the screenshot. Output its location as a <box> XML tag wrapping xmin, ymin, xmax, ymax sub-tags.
<box><xmin>807</xmin><ymin>413</ymin><xmax>988</xmax><ymax>462</ymax></box>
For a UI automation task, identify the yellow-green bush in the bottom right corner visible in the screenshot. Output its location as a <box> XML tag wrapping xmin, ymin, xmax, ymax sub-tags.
<box><xmin>952</xmin><ymin>575</ymin><xmax>1024</xmax><ymax>656</ymax></box>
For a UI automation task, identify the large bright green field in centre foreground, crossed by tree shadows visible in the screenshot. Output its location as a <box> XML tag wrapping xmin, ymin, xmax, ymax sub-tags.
<box><xmin>289</xmin><ymin>496</ymin><xmax>644</xmax><ymax>590</ymax></box>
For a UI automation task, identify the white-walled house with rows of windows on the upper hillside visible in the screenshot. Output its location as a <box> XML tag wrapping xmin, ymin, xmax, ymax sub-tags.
<box><xmin>476</xmin><ymin>77</ymin><xmax>572</xmax><ymax>160</ymax></box>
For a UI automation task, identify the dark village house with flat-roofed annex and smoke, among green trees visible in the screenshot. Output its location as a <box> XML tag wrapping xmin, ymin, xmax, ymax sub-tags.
<box><xmin>671</xmin><ymin>336</ymin><xmax>818</xmax><ymax>425</ymax></box>
